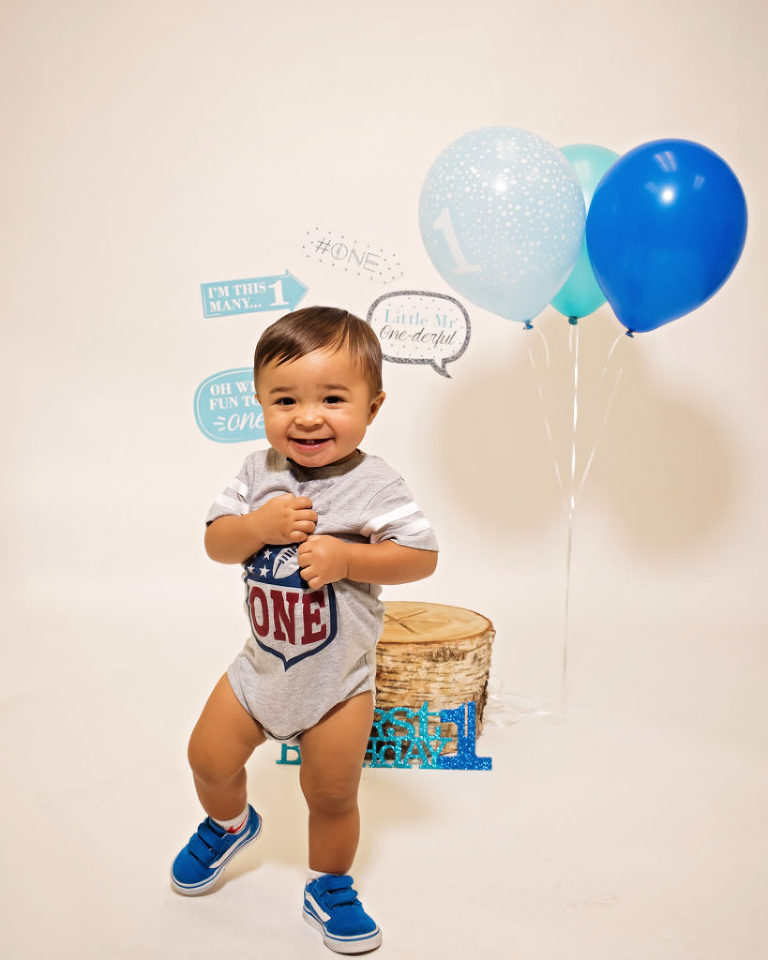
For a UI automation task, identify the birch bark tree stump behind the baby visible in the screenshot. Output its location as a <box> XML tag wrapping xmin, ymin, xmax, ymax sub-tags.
<box><xmin>376</xmin><ymin>601</ymin><xmax>496</xmax><ymax>753</ymax></box>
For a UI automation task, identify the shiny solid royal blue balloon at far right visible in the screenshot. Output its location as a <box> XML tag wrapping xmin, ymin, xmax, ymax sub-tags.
<box><xmin>586</xmin><ymin>140</ymin><xmax>747</xmax><ymax>332</ymax></box>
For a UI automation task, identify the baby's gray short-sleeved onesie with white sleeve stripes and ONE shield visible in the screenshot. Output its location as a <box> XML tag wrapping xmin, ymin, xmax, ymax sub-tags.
<box><xmin>207</xmin><ymin>449</ymin><xmax>437</xmax><ymax>740</ymax></box>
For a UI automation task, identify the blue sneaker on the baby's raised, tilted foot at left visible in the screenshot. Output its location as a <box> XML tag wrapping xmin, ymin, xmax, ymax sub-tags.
<box><xmin>171</xmin><ymin>804</ymin><xmax>261</xmax><ymax>897</ymax></box>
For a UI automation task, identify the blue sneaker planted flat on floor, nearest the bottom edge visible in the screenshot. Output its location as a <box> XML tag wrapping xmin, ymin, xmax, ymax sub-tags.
<box><xmin>304</xmin><ymin>873</ymin><xmax>381</xmax><ymax>953</ymax></box>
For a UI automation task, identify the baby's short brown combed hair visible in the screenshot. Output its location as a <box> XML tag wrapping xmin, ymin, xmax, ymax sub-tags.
<box><xmin>253</xmin><ymin>307</ymin><xmax>382</xmax><ymax>397</ymax></box>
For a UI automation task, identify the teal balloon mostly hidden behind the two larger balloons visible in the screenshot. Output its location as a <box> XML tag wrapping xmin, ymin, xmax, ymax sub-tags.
<box><xmin>552</xmin><ymin>143</ymin><xmax>619</xmax><ymax>319</ymax></box>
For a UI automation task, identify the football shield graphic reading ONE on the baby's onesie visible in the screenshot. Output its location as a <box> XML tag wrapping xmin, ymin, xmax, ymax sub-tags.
<box><xmin>243</xmin><ymin>544</ymin><xmax>337</xmax><ymax>670</ymax></box>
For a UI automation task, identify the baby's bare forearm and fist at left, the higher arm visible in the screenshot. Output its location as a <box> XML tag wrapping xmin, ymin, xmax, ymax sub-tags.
<box><xmin>205</xmin><ymin>493</ymin><xmax>317</xmax><ymax>563</ymax></box>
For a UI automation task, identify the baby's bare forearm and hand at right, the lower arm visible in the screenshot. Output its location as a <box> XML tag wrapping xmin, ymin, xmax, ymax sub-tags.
<box><xmin>299</xmin><ymin>536</ymin><xmax>437</xmax><ymax>590</ymax></box>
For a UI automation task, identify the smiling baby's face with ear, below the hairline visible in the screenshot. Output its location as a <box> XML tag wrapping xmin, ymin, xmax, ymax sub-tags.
<box><xmin>256</xmin><ymin>347</ymin><xmax>384</xmax><ymax>467</ymax></box>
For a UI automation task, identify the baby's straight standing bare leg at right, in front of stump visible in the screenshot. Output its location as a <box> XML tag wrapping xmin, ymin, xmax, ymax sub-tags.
<box><xmin>300</xmin><ymin>693</ymin><xmax>373</xmax><ymax>873</ymax></box>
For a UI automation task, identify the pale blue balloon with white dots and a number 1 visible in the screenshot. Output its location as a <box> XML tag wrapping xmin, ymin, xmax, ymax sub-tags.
<box><xmin>419</xmin><ymin>127</ymin><xmax>585</xmax><ymax>323</ymax></box>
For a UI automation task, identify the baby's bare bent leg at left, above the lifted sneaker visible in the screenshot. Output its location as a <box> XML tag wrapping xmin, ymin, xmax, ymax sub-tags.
<box><xmin>188</xmin><ymin>674</ymin><xmax>266</xmax><ymax>820</ymax></box>
